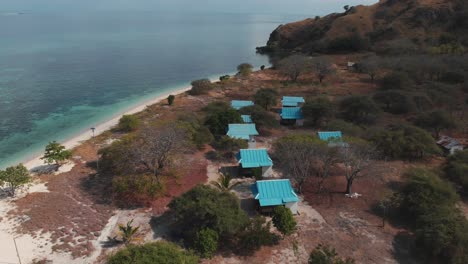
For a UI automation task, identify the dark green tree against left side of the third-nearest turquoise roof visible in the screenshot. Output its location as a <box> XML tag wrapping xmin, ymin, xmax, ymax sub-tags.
<box><xmin>205</xmin><ymin>108</ymin><xmax>243</xmax><ymax>136</ymax></box>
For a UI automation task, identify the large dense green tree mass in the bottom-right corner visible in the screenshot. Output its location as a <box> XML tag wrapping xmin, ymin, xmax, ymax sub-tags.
<box><xmin>395</xmin><ymin>169</ymin><xmax>468</xmax><ymax>264</ymax></box>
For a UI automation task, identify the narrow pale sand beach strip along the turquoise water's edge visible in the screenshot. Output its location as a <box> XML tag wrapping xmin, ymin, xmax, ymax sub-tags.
<box><xmin>22</xmin><ymin>85</ymin><xmax>192</xmax><ymax>170</ymax></box>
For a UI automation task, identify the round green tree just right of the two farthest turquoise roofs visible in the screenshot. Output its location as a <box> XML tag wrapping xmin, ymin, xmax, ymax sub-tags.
<box><xmin>302</xmin><ymin>97</ymin><xmax>335</xmax><ymax>127</ymax></box>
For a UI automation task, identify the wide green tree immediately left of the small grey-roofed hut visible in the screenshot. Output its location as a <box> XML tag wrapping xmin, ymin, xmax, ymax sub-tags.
<box><xmin>370</xmin><ymin>125</ymin><xmax>441</xmax><ymax>160</ymax></box>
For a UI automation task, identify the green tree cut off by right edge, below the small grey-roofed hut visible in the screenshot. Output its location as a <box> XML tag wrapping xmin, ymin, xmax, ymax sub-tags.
<box><xmin>444</xmin><ymin>150</ymin><xmax>468</xmax><ymax>191</ymax></box>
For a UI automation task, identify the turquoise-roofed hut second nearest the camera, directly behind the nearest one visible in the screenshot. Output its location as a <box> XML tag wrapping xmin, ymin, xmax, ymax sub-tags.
<box><xmin>237</xmin><ymin>149</ymin><xmax>273</xmax><ymax>177</ymax></box>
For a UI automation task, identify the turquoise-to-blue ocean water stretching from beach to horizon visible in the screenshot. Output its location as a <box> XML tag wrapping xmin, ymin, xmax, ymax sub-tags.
<box><xmin>0</xmin><ymin>9</ymin><xmax>305</xmax><ymax>168</ymax></box>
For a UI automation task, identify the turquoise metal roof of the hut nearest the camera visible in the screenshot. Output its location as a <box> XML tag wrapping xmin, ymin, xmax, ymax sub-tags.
<box><xmin>250</xmin><ymin>179</ymin><xmax>299</xmax><ymax>206</ymax></box>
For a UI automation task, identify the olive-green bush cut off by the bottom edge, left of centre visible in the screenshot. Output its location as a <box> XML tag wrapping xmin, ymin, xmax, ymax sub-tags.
<box><xmin>107</xmin><ymin>242</ymin><xmax>199</xmax><ymax>264</ymax></box>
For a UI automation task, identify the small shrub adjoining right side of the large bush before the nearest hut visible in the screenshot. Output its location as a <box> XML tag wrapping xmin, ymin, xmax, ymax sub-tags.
<box><xmin>238</xmin><ymin>216</ymin><xmax>279</xmax><ymax>255</ymax></box>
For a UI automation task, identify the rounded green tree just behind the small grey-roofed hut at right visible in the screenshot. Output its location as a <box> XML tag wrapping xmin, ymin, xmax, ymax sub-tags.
<box><xmin>414</xmin><ymin>110</ymin><xmax>456</xmax><ymax>138</ymax></box>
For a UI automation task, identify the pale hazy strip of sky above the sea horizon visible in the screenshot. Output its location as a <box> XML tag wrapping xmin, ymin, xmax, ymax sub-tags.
<box><xmin>0</xmin><ymin>0</ymin><xmax>378</xmax><ymax>16</ymax></box>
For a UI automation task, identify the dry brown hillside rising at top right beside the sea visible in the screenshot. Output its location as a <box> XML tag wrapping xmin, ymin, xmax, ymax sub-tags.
<box><xmin>260</xmin><ymin>0</ymin><xmax>468</xmax><ymax>53</ymax></box>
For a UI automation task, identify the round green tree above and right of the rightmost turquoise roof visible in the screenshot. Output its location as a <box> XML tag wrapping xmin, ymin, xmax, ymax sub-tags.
<box><xmin>340</xmin><ymin>95</ymin><xmax>379</xmax><ymax>124</ymax></box>
